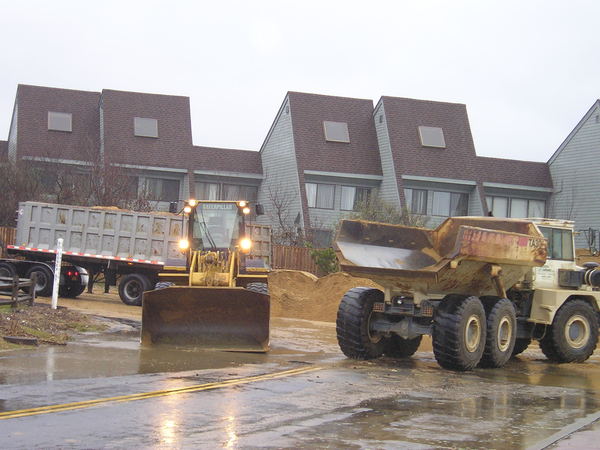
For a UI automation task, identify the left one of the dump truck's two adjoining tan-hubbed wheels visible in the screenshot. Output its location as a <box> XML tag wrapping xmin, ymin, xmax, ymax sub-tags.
<box><xmin>433</xmin><ymin>296</ymin><xmax>486</xmax><ymax>371</ymax></box>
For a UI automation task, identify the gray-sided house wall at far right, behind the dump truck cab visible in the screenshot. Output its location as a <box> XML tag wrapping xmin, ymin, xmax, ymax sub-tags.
<box><xmin>549</xmin><ymin>103</ymin><xmax>600</xmax><ymax>247</ymax></box>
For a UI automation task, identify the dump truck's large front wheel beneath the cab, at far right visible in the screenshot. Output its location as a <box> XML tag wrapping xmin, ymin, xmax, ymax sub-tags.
<box><xmin>540</xmin><ymin>300</ymin><xmax>598</xmax><ymax>363</ymax></box>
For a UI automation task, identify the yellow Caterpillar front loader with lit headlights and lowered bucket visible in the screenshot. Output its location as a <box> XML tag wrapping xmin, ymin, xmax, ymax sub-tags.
<box><xmin>142</xmin><ymin>200</ymin><xmax>270</xmax><ymax>352</ymax></box>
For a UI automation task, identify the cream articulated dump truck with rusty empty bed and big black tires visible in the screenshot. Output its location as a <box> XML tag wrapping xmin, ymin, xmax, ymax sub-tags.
<box><xmin>336</xmin><ymin>217</ymin><xmax>600</xmax><ymax>371</ymax></box>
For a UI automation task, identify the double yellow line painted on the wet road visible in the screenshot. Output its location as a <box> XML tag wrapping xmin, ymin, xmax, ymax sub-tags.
<box><xmin>0</xmin><ymin>367</ymin><xmax>321</xmax><ymax>420</ymax></box>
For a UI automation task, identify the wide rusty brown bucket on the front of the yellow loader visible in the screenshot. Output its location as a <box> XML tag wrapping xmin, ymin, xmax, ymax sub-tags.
<box><xmin>142</xmin><ymin>286</ymin><xmax>269</xmax><ymax>352</ymax></box>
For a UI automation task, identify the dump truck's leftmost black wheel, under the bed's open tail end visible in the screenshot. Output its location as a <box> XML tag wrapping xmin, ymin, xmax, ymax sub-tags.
<box><xmin>336</xmin><ymin>287</ymin><xmax>385</xmax><ymax>359</ymax></box>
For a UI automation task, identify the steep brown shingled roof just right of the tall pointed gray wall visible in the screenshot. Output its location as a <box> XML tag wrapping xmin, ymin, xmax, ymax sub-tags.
<box><xmin>288</xmin><ymin>92</ymin><xmax>381</xmax><ymax>175</ymax></box>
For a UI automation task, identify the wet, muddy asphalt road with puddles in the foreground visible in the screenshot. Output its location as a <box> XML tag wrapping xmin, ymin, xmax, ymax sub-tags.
<box><xmin>0</xmin><ymin>296</ymin><xmax>600</xmax><ymax>448</ymax></box>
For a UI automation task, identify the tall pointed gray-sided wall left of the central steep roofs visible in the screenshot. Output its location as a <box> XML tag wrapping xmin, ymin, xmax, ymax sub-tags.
<box><xmin>258</xmin><ymin>97</ymin><xmax>304</xmax><ymax>230</ymax></box>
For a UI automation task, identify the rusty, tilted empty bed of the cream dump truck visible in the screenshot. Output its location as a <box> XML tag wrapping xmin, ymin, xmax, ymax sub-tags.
<box><xmin>336</xmin><ymin>217</ymin><xmax>546</xmax><ymax>295</ymax></box>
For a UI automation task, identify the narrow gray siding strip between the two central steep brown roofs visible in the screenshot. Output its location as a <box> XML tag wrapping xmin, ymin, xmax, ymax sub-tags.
<box><xmin>373</xmin><ymin>102</ymin><xmax>400</xmax><ymax>208</ymax></box>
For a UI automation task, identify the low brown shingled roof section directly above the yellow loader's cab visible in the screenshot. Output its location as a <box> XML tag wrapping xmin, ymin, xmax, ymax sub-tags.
<box><xmin>190</xmin><ymin>145</ymin><xmax>262</xmax><ymax>175</ymax></box>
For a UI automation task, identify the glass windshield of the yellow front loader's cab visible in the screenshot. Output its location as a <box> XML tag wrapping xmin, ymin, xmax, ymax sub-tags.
<box><xmin>192</xmin><ymin>203</ymin><xmax>239</xmax><ymax>250</ymax></box>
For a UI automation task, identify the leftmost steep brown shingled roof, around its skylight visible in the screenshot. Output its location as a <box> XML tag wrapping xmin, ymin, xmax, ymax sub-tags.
<box><xmin>17</xmin><ymin>84</ymin><xmax>100</xmax><ymax>161</ymax></box>
